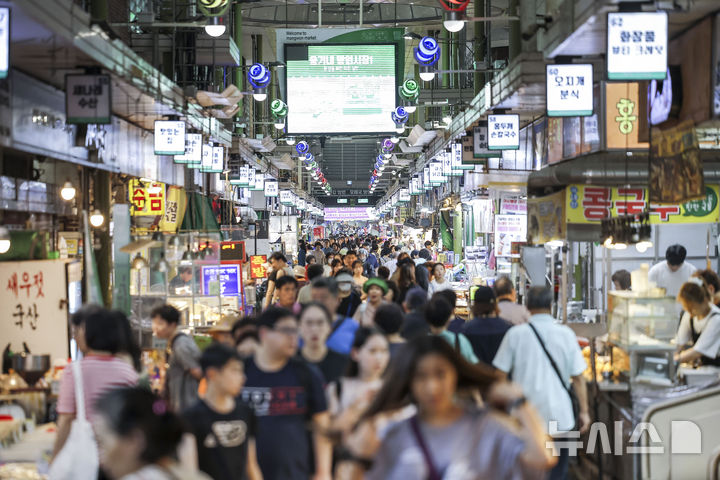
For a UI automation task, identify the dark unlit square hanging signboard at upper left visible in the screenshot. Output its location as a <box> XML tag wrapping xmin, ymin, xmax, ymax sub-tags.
<box><xmin>66</xmin><ymin>73</ymin><xmax>112</xmax><ymax>125</ymax></box>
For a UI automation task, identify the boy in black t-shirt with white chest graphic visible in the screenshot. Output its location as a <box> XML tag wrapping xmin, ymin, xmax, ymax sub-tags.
<box><xmin>183</xmin><ymin>343</ymin><xmax>263</xmax><ymax>480</ymax></box>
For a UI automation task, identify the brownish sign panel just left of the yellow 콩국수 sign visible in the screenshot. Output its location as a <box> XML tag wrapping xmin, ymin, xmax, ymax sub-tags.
<box><xmin>527</xmin><ymin>190</ymin><xmax>566</xmax><ymax>245</ymax></box>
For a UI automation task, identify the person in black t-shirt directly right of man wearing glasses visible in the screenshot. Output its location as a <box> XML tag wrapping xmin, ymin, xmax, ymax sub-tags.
<box><xmin>300</xmin><ymin>302</ymin><xmax>350</xmax><ymax>385</ymax></box>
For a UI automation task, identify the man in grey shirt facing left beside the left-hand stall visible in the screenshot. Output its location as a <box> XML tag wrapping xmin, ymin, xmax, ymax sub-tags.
<box><xmin>150</xmin><ymin>305</ymin><xmax>202</xmax><ymax>413</ymax></box>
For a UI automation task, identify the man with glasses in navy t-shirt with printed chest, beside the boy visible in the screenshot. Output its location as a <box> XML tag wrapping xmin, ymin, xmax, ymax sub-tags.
<box><xmin>241</xmin><ymin>307</ymin><xmax>332</xmax><ymax>480</ymax></box>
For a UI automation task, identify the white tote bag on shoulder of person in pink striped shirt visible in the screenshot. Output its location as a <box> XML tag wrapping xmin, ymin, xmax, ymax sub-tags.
<box><xmin>49</xmin><ymin>361</ymin><xmax>100</xmax><ymax>480</ymax></box>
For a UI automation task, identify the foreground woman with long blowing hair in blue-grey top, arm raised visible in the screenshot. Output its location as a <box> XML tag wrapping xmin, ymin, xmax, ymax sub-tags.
<box><xmin>349</xmin><ymin>336</ymin><xmax>556</xmax><ymax>480</ymax></box>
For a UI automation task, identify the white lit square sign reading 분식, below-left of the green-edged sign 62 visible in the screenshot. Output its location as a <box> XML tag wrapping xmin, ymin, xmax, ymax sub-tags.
<box><xmin>545</xmin><ymin>63</ymin><xmax>593</xmax><ymax>117</ymax></box>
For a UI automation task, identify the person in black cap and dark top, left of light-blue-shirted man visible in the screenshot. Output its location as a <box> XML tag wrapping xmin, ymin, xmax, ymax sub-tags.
<box><xmin>462</xmin><ymin>286</ymin><xmax>512</xmax><ymax>365</ymax></box>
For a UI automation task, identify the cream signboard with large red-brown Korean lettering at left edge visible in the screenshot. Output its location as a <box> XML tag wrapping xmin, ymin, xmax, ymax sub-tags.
<box><xmin>0</xmin><ymin>260</ymin><xmax>70</xmax><ymax>366</ymax></box>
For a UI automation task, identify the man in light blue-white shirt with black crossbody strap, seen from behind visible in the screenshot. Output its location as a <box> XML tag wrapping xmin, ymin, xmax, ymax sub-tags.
<box><xmin>493</xmin><ymin>287</ymin><xmax>590</xmax><ymax>479</ymax></box>
